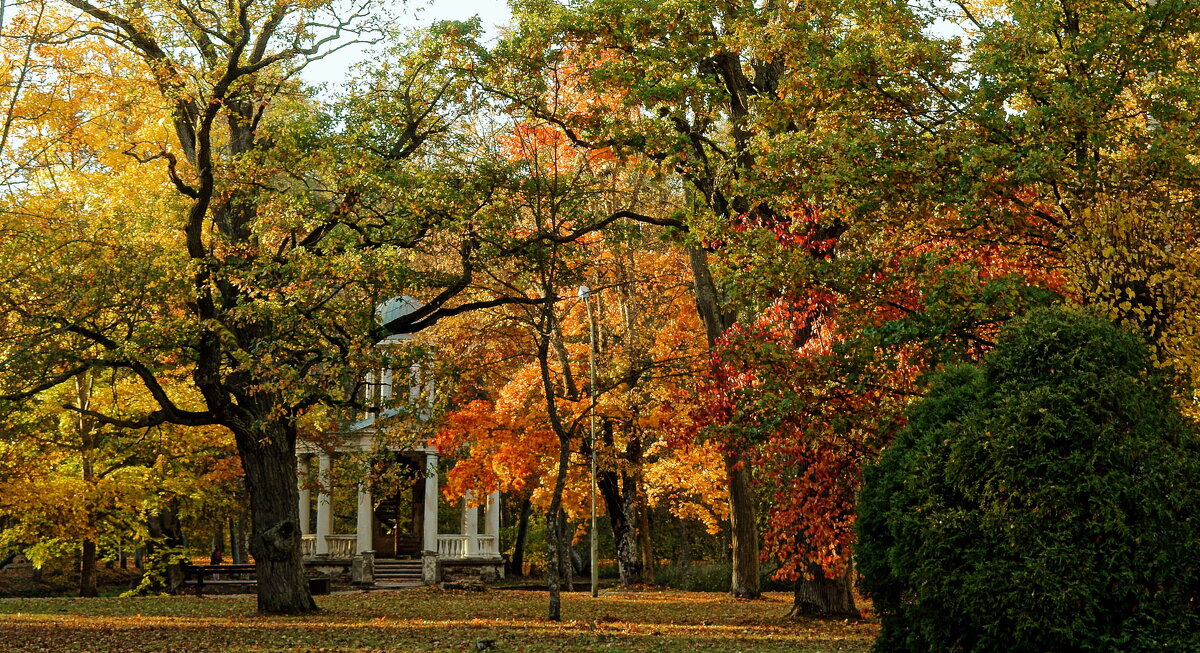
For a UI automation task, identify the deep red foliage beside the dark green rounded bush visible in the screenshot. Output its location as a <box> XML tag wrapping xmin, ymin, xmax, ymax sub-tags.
<box><xmin>691</xmin><ymin>206</ymin><xmax>1062</xmax><ymax>579</ymax></box>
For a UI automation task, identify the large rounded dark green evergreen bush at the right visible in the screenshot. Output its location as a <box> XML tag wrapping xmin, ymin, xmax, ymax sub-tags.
<box><xmin>858</xmin><ymin>310</ymin><xmax>1200</xmax><ymax>652</ymax></box>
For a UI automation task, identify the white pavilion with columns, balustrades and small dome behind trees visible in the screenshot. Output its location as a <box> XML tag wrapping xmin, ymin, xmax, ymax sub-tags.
<box><xmin>296</xmin><ymin>298</ymin><xmax>504</xmax><ymax>587</ymax></box>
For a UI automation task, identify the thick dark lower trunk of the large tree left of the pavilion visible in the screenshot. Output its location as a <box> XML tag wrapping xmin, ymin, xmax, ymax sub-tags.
<box><xmin>233</xmin><ymin>421</ymin><xmax>317</xmax><ymax>615</ymax></box>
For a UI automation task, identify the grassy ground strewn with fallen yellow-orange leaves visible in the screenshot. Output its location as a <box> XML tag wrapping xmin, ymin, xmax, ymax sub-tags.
<box><xmin>0</xmin><ymin>588</ymin><xmax>877</xmax><ymax>653</ymax></box>
